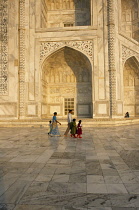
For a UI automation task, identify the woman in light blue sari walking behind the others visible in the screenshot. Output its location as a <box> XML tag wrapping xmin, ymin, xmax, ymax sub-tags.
<box><xmin>49</xmin><ymin>112</ymin><xmax>61</xmax><ymax>136</ymax></box>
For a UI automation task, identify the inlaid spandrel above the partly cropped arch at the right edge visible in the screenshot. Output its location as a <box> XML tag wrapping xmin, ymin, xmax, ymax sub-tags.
<box><xmin>122</xmin><ymin>45</ymin><xmax>139</xmax><ymax>65</ymax></box>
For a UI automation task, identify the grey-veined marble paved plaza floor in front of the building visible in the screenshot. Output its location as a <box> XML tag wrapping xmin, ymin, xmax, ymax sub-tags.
<box><xmin>0</xmin><ymin>125</ymin><xmax>139</xmax><ymax>210</ymax></box>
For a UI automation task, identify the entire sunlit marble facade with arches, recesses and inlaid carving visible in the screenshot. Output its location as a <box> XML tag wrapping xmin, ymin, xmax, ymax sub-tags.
<box><xmin>0</xmin><ymin>0</ymin><xmax>139</xmax><ymax>120</ymax></box>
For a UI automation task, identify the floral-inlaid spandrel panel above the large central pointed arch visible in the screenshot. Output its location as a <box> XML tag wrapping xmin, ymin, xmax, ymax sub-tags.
<box><xmin>40</xmin><ymin>40</ymin><xmax>93</xmax><ymax>62</ymax></box>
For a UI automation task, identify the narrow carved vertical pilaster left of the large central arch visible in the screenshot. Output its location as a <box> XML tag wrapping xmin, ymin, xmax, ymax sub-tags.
<box><xmin>19</xmin><ymin>0</ymin><xmax>25</xmax><ymax>117</ymax></box>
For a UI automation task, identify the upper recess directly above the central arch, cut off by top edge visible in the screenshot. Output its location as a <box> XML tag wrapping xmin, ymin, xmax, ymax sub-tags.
<box><xmin>40</xmin><ymin>0</ymin><xmax>91</xmax><ymax>28</ymax></box>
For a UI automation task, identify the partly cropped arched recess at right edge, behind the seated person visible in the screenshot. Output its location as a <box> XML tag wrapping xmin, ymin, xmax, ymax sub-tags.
<box><xmin>123</xmin><ymin>56</ymin><xmax>139</xmax><ymax>117</ymax></box>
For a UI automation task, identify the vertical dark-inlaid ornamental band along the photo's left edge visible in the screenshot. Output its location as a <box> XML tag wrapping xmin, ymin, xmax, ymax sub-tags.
<box><xmin>0</xmin><ymin>0</ymin><xmax>8</xmax><ymax>95</ymax></box>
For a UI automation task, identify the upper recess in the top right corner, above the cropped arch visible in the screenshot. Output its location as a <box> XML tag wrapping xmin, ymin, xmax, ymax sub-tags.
<box><xmin>121</xmin><ymin>0</ymin><xmax>139</xmax><ymax>41</ymax></box>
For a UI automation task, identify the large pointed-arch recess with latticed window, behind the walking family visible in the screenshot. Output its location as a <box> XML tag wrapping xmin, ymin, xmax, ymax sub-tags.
<box><xmin>41</xmin><ymin>47</ymin><xmax>93</xmax><ymax>118</ymax></box>
